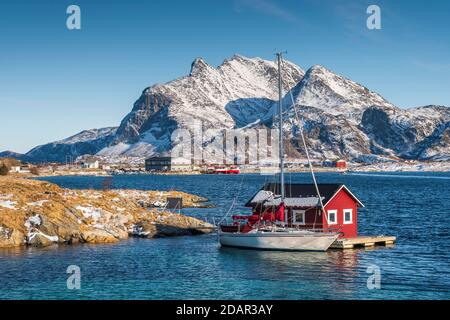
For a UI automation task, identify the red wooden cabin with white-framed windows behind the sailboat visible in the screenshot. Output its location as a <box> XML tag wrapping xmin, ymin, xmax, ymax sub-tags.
<box><xmin>246</xmin><ymin>183</ymin><xmax>364</xmax><ymax>238</ymax></box>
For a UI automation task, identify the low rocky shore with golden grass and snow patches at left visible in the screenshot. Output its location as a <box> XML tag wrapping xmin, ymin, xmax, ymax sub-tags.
<box><xmin>0</xmin><ymin>177</ymin><xmax>212</xmax><ymax>248</ymax></box>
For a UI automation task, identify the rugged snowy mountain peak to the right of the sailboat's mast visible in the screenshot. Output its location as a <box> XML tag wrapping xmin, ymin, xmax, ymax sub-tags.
<box><xmin>266</xmin><ymin>66</ymin><xmax>450</xmax><ymax>161</ymax></box>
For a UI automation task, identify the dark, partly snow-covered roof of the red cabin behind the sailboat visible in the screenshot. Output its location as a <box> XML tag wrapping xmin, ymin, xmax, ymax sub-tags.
<box><xmin>245</xmin><ymin>183</ymin><xmax>364</xmax><ymax>207</ymax></box>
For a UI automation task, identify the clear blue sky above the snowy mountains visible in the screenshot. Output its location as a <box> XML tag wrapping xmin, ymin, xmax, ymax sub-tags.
<box><xmin>0</xmin><ymin>0</ymin><xmax>450</xmax><ymax>152</ymax></box>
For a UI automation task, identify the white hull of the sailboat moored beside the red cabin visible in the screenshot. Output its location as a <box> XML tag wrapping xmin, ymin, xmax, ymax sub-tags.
<box><xmin>219</xmin><ymin>232</ymin><xmax>338</xmax><ymax>251</ymax></box>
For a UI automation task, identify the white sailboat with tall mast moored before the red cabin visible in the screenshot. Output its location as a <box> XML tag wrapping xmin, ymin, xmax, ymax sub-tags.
<box><xmin>218</xmin><ymin>53</ymin><xmax>339</xmax><ymax>251</ymax></box>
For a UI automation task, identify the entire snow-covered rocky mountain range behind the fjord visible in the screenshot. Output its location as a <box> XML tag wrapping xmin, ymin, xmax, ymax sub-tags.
<box><xmin>10</xmin><ymin>55</ymin><xmax>450</xmax><ymax>162</ymax></box>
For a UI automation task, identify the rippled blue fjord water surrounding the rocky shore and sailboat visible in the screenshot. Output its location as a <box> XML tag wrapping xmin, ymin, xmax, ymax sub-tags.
<box><xmin>0</xmin><ymin>173</ymin><xmax>450</xmax><ymax>300</ymax></box>
